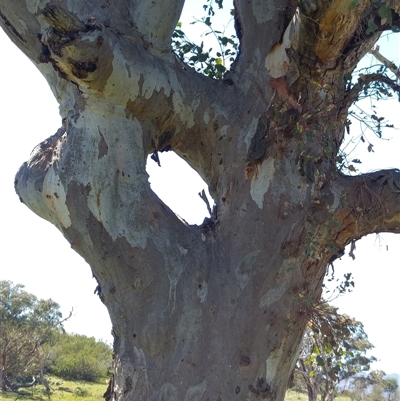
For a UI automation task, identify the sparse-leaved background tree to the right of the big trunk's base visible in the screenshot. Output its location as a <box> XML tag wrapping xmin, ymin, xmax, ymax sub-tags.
<box><xmin>296</xmin><ymin>303</ymin><xmax>375</xmax><ymax>401</ymax></box>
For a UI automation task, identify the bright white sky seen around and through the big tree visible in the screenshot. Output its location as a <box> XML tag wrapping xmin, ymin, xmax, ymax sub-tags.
<box><xmin>0</xmin><ymin>2</ymin><xmax>400</xmax><ymax>373</ymax></box>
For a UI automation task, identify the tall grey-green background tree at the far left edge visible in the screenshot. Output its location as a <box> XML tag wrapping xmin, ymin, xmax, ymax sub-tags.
<box><xmin>0</xmin><ymin>281</ymin><xmax>62</xmax><ymax>390</ymax></box>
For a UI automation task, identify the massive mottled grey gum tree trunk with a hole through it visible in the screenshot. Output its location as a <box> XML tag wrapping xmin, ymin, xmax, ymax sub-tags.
<box><xmin>0</xmin><ymin>0</ymin><xmax>400</xmax><ymax>401</ymax></box>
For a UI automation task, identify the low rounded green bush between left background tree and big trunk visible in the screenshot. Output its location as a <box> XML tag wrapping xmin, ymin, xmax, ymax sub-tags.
<box><xmin>49</xmin><ymin>333</ymin><xmax>112</xmax><ymax>382</ymax></box>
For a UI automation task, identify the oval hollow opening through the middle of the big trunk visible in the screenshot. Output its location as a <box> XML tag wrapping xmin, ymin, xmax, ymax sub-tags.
<box><xmin>146</xmin><ymin>151</ymin><xmax>214</xmax><ymax>225</ymax></box>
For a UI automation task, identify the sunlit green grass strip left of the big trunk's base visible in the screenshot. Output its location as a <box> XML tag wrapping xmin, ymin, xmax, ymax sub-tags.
<box><xmin>0</xmin><ymin>377</ymin><xmax>108</xmax><ymax>401</ymax></box>
